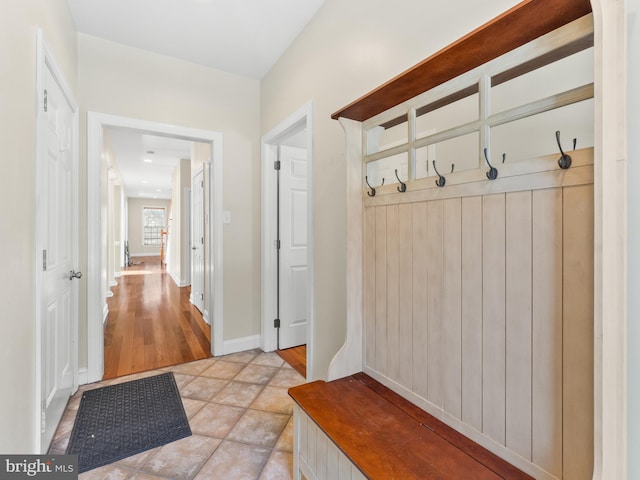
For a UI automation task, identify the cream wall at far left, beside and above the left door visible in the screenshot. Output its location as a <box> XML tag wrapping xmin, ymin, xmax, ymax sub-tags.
<box><xmin>0</xmin><ymin>0</ymin><xmax>77</xmax><ymax>453</ymax></box>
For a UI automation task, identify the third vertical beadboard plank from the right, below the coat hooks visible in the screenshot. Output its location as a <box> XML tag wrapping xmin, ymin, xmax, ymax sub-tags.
<box><xmin>505</xmin><ymin>191</ymin><xmax>533</xmax><ymax>460</ymax></box>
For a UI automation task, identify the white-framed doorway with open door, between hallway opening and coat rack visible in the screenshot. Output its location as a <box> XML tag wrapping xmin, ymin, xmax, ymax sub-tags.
<box><xmin>262</xmin><ymin>103</ymin><xmax>313</xmax><ymax>378</ymax></box>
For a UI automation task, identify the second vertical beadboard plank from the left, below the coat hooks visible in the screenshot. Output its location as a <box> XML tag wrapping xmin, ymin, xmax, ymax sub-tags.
<box><xmin>371</xmin><ymin>207</ymin><xmax>387</xmax><ymax>375</ymax></box>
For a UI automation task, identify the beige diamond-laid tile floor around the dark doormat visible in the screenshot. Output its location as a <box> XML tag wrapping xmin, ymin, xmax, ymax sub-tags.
<box><xmin>50</xmin><ymin>350</ymin><xmax>305</xmax><ymax>480</ymax></box>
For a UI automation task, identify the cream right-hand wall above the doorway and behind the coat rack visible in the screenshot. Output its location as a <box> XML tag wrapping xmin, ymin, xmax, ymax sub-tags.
<box><xmin>262</xmin><ymin>0</ymin><xmax>518</xmax><ymax>378</ymax></box>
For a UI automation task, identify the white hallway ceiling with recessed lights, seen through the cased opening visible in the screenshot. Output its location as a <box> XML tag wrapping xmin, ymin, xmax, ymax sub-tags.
<box><xmin>106</xmin><ymin>127</ymin><xmax>193</xmax><ymax>200</ymax></box>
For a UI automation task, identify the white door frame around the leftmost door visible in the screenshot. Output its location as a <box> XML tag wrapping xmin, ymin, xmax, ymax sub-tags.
<box><xmin>34</xmin><ymin>29</ymin><xmax>79</xmax><ymax>453</ymax></box>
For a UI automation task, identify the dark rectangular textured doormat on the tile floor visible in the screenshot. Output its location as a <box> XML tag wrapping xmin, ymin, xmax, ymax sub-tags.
<box><xmin>67</xmin><ymin>372</ymin><xmax>191</xmax><ymax>473</ymax></box>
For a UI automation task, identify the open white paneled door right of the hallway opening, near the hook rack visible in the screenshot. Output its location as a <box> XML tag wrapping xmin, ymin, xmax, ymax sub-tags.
<box><xmin>280</xmin><ymin>145</ymin><xmax>309</xmax><ymax>349</ymax></box>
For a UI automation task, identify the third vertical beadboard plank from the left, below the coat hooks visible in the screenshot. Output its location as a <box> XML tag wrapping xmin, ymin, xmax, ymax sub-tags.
<box><xmin>385</xmin><ymin>205</ymin><xmax>400</xmax><ymax>378</ymax></box>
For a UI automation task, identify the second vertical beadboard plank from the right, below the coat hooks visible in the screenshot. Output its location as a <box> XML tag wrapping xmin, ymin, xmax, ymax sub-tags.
<box><xmin>531</xmin><ymin>188</ymin><xmax>562</xmax><ymax>478</ymax></box>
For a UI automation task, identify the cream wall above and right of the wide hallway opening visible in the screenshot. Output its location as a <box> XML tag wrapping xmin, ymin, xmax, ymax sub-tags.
<box><xmin>78</xmin><ymin>34</ymin><xmax>260</xmax><ymax>348</ymax></box>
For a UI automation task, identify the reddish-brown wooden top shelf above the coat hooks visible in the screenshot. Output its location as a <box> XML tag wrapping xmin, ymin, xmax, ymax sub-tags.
<box><xmin>331</xmin><ymin>0</ymin><xmax>591</xmax><ymax>122</ymax></box>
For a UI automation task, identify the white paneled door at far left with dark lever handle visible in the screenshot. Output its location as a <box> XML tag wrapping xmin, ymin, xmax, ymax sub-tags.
<box><xmin>39</xmin><ymin>62</ymin><xmax>81</xmax><ymax>449</ymax></box>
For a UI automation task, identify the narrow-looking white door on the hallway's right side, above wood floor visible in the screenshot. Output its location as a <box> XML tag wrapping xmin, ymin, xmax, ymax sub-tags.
<box><xmin>191</xmin><ymin>167</ymin><xmax>204</xmax><ymax>312</ymax></box>
